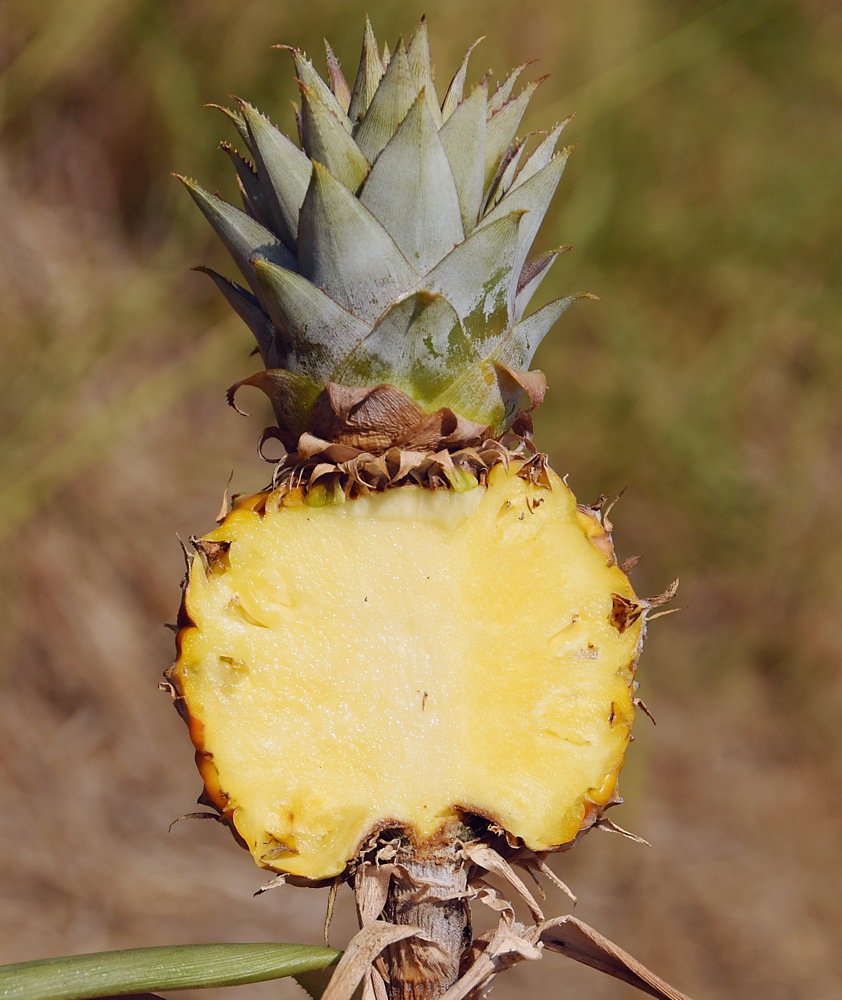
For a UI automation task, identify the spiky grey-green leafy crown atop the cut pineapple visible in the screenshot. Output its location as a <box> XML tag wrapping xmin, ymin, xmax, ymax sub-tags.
<box><xmin>180</xmin><ymin>19</ymin><xmax>586</xmax><ymax>454</ymax></box>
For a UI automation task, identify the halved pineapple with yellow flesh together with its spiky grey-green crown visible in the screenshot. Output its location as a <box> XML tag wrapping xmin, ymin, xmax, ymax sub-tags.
<box><xmin>162</xmin><ymin>22</ymin><xmax>668</xmax><ymax>996</ymax></box>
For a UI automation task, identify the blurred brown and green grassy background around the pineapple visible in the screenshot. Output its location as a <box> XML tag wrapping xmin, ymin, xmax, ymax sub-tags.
<box><xmin>0</xmin><ymin>0</ymin><xmax>842</xmax><ymax>1000</ymax></box>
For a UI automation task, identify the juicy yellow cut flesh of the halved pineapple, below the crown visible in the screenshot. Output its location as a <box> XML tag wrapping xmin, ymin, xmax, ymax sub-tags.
<box><xmin>170</xmin><ymin>464</ymin><xmax>643</xmax><ymax>880</ymax></box>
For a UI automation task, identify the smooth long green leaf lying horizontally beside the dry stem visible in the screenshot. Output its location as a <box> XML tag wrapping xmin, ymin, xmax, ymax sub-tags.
<box><xmin>0</xmin><ymin>944</ymin><xmax>342</xmax><ymax>1000</ymax></box>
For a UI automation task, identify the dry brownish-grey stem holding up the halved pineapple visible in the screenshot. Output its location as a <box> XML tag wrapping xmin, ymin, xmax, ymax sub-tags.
<box><xmin>370</xmin><ymin>845</ymin><xmax>471</xmax><ymax>1000</ymax></box>
